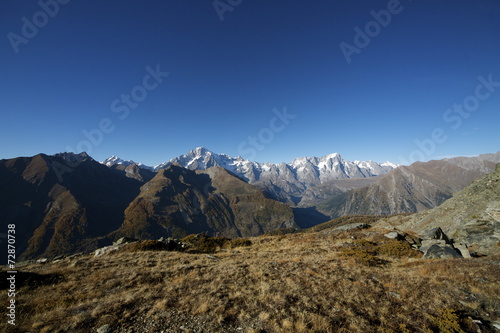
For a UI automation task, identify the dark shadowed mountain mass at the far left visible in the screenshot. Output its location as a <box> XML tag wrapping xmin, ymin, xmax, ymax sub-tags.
<box><xmin>0</xmin><ymin>153</ymin><xmax>141</xmax><ymax>259</ymax></box>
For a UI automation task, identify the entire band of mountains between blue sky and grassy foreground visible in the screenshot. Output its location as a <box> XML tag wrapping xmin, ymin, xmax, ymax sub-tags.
<box><xmin>0</xmin><ymin>148</ymin><xmax>500</xmax><ymax>260</ymax></box>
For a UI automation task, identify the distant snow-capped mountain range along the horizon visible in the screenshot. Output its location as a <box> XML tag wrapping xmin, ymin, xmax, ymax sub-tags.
<box><xmin>102</xmin><ymin>147</ymin><xmax>398</xmax><ymax>204</ymax></box>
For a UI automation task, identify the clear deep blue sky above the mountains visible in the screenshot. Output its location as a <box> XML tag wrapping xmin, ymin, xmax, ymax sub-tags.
<box><xmin>0</xmin><ymin>0</ymin><xmax>500</xmax><ymax>165</ymax></box>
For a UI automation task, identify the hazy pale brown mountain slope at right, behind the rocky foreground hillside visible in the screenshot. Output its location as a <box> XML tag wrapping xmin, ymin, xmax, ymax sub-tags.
<box><xmin>318</xmin><ymin>152</ymin><xmax>500</xmax><ymax>217</ymax></box>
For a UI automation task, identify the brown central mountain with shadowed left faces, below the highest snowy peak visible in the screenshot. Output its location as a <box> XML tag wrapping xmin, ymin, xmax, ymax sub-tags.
<box><xmin>115</xmin><ymin>164</ymin><xmax>298</xmax><ymax>239</ymax></box>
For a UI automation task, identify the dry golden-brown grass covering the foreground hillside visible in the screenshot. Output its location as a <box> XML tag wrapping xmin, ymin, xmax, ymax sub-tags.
<box><xmin>0</xmin><ymin>231</ymin><xmax>500</xmax><ymax>333</ymax></box>
